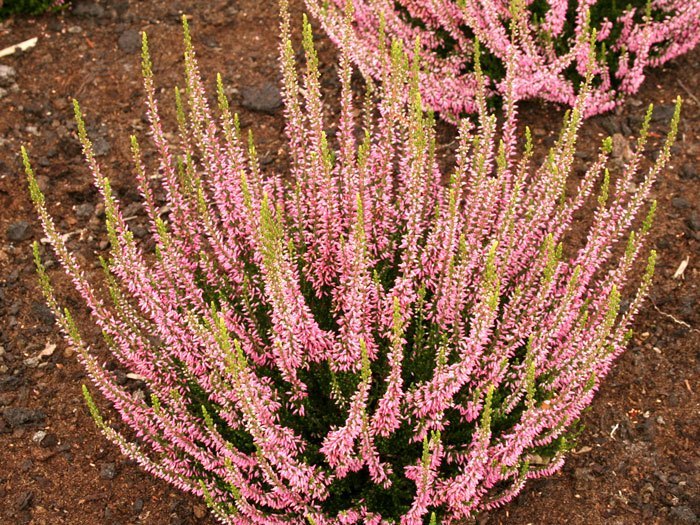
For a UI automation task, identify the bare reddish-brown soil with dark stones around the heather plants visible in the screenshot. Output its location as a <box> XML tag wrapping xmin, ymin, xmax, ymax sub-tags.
<box><xmin>0</xmin><ymin>0</ymin><xmax>700</xmax><ymax>525</ymax></box>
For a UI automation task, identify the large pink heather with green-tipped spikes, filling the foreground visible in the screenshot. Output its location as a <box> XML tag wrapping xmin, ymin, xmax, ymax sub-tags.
<box><xmin>23</xmin><ymin>6</ymin><xmax>680</xmax><ymax>525</ymax></box>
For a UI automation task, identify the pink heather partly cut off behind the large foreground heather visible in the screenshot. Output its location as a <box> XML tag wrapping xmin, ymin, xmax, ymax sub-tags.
<box><xmin>306</xmin><ymin>0</ymin><xmax>700</xmax><ymax>119</ymax></box>
